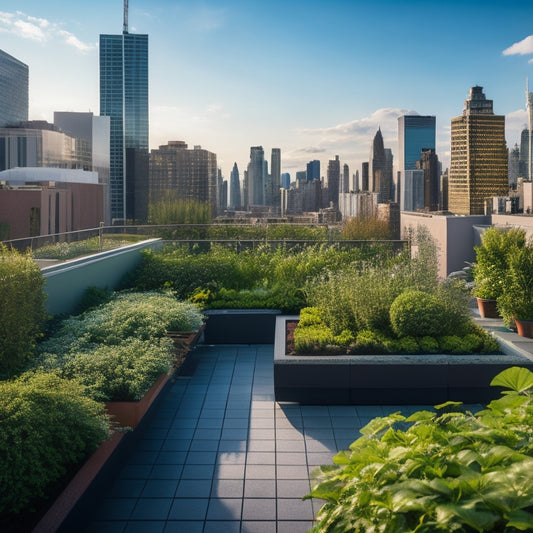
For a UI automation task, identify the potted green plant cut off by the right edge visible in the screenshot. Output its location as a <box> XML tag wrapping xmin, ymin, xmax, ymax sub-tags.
<box><xmin>498</xmin><ymin>241</ymin><xmax>533</xmax><ymax>338</ymax></box>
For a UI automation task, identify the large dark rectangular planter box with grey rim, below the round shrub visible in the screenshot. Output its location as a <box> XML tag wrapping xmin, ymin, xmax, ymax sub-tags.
<box><xmin>274</xmin><ymin>316</ymin><xmax>533</xmax><ymax>405</ymax></box>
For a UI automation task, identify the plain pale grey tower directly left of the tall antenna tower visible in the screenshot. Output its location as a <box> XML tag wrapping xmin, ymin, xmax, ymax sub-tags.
<box><xmin>54</xmin><ymin>111</ymin><xmax>111</xmax><ymax>225</ymax></box>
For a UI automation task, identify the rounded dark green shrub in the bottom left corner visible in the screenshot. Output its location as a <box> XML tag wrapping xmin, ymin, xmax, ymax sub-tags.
<box><xmin>0</xmin><ymin>373</ymin><xmax>109</xmax><ymax>516</ymax></box>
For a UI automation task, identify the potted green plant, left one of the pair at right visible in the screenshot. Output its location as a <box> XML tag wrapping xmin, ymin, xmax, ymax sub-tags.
<box><xmin>472</xmin><ymin>228</ymin><xmax>525</xmax><ymax>318</ymax></box>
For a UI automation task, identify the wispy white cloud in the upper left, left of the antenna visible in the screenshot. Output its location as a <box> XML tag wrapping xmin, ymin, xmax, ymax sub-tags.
<box><xmin>0</xmin><ymin>11</ymin><xmax>96</xmax><ymax>53</ymax></box>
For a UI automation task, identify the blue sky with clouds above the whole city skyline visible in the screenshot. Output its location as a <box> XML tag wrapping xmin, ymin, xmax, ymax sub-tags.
<box><xmin>0</xmin><ymin>0</ymin><xmax>533</xmax><ymax>178</ymax></box>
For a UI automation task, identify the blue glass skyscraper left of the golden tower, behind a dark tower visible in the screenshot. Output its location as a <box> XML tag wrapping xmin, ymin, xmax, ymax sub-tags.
<box><xmin>395</xmin><ymin>115</ymin><xmax>436</xmax><ymax>206</ymax></box>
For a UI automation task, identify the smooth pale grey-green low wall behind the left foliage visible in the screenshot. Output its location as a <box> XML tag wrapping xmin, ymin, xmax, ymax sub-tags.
<box><xmin>41</xmin><ymin>239</ymin><xmax>162</xmax><ymax>315</ymax></box>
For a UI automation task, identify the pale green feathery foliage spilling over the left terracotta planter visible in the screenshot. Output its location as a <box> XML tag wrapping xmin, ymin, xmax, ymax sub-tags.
<box><xmin>34</xmin><ymin>292</ymin><xmax>203</xmax><ymax>401</ymax></box>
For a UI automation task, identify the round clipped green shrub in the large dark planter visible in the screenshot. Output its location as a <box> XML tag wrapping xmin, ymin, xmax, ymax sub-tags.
<box><xmin>389</xmin><ymin>291</ymin><xmax>444</xmax><ymax>337</ymax></box>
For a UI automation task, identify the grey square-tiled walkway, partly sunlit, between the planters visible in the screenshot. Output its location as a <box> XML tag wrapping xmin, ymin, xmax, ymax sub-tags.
<box><xmin>87</xmin><ymin>345</ymin><xmax>440</xmax><ymax>533</ymax></box>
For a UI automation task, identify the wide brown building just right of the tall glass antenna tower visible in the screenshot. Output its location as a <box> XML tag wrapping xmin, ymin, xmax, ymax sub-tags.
<box><xmin>150</xmin><ymin>141</ymin><xmax>218</xmax><ymax>216</ymax></box>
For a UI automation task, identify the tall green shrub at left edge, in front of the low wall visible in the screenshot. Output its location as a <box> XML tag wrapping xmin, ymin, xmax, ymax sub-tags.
<box><xmin>0</xmin><ymin>245</ymin><xmax>46</xmax><ymax>377</ymax></box>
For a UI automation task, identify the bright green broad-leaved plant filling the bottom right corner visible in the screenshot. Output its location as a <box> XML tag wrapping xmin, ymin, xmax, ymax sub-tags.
<box><xmin>304</xmin><ymin>367</ymin><xmax>533</xmax><ymax>533</ymax></box>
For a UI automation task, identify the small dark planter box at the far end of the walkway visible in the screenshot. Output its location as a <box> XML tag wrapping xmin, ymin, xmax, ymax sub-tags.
<box><xmin>204</xmin><ymin>309</ymin><xmax>281</xmax><ymax>344</ymax></box>
